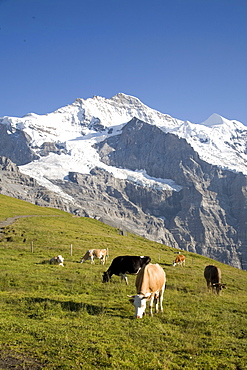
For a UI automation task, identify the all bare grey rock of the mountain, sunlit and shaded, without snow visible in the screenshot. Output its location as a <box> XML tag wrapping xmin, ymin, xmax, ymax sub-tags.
<box><xmin>0</xmin><ymin>109</ymin><xmax>247</xmax><ymax>269</ymax></box>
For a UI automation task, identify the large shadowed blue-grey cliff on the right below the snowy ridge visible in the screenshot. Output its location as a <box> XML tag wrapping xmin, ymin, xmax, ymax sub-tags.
<box><xmin>97</xmin><ymin>119</ymin><xmax>247</xmax><ymax>269</ymax></box>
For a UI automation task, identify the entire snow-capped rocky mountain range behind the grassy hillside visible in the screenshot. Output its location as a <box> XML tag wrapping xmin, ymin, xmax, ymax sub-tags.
<box><xmin>0</xmin><ymin>93</ymin><xmax>247</xmax><ymax>269</ymax></box>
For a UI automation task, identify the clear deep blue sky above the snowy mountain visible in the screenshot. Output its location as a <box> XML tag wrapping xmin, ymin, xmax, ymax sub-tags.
<box><xmin>0</xmin><ymin>0</ymin><xmax>247</xmax><ymax>125</ymax></box>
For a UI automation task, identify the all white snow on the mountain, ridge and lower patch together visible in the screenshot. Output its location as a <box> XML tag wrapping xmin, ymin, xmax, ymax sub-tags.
<box><xmin>0</xmin><ymin>93</ymin><xmax>247</xmax><ymax>197</ymax></box>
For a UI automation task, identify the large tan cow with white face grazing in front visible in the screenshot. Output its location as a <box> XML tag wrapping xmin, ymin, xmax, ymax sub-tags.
<box><xmin>128</xmin><ymin>263</ymin><xmax>166</xmax><ymax>319</ymax></box>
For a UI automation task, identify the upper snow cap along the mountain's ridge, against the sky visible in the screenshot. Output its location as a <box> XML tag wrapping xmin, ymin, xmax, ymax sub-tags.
<box><xmin>0</xmin><ymin>93</ymin><xmax>247</xmax><ymax>174</ymax></box>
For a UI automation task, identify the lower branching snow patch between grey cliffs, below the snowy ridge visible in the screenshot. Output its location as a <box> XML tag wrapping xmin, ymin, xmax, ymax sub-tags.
<box><xmin>19</xmin><ymin>130</ymin><xmax>181</xmax><ymax>198</ymax></box>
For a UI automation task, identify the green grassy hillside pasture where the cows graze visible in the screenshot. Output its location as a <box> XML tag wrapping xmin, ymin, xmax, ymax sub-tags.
<box><xmin>0</xmin><ymin>195</ymin><xmax>247</xmax><ymax>370</ymax></box>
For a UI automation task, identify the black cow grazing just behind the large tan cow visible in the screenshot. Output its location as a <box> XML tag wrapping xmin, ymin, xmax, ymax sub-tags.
<box><xmin>103</xmin><ymin>256</ymin><xmax>151</xmax><ymax>285</ymax></box>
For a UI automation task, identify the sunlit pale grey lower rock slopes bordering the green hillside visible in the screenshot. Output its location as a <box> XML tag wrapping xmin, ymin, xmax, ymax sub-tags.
<box><xmin>0</xmin><ymin>157</ymin><xmax>179</xmax><ymax>248</ymax></box>
